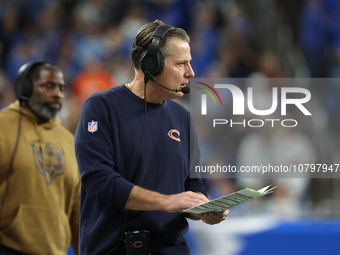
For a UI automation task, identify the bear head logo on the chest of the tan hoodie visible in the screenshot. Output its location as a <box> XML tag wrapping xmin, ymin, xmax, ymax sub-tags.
<box><xmin>31</xmin><ymin>141</ymin><xmax>65</xmax><ymax>185</ymax></box>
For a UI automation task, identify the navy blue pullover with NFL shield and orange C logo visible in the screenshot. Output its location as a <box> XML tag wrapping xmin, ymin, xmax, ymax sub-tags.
<box><xmin>75</xmin><ymin>85</ymin><xmax>206</xmax><ymax>255</ymax></box>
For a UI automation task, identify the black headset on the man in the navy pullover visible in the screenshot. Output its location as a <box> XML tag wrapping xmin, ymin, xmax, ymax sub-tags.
<box><xmin>140</xmin><ymin>24</ymin><xmax>174</xmax><ymax>76</ymax></box>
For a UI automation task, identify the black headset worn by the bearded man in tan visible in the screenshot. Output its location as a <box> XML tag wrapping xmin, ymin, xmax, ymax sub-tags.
<box><xmin>14</xmin><ymin>61</ymin><xmax>48</xmax><ymax>103</ymax></box>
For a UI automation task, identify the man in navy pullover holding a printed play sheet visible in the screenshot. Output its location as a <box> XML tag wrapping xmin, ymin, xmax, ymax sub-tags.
<box><xmin>75</xmin><ymin>20</ymin><xmax>228</xmax><ymax>255</ymax></box>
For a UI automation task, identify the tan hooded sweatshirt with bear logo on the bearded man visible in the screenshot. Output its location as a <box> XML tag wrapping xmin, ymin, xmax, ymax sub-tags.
<box><xmin>0</xmin><ymin>101</ymin><xmax>80</xmax><ymax>255</ymax></box>
